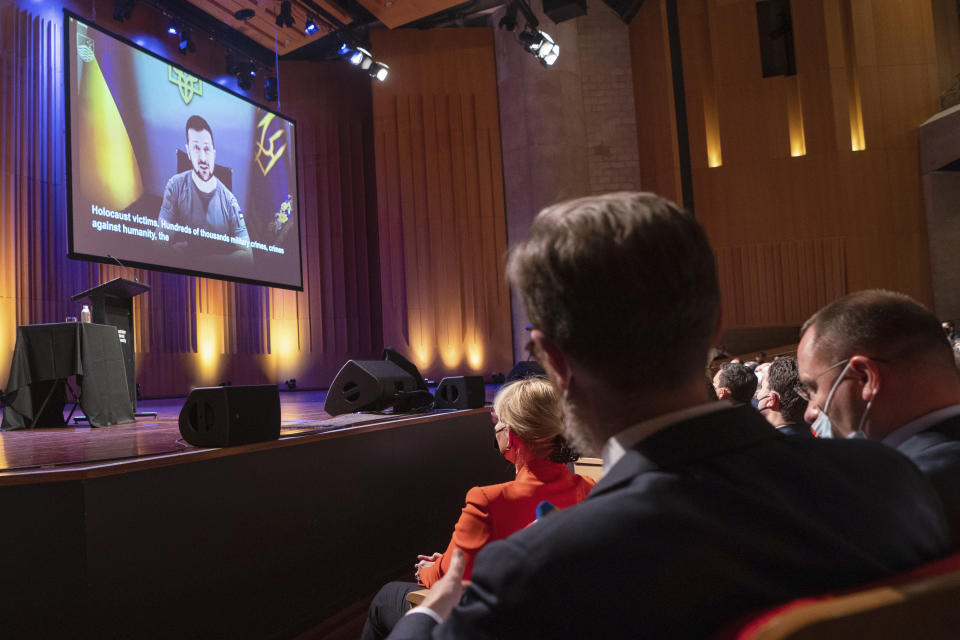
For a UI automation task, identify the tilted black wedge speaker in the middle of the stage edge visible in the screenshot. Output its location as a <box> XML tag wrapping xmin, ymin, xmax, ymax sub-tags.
<box><xmin>323</xmin><ymin>360</ymin><xmax>417</xmax><ymax>416</ymax></box>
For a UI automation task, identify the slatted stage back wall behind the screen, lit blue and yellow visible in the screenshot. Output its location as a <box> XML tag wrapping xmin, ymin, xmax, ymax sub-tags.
<box><xmin>0</xmin><ymin>0</ymin><xmax>383</xmax><ymax>397</ymax></box>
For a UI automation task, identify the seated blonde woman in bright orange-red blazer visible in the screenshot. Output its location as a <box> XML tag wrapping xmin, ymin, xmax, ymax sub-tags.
<box><xmin>362</xmin><ymin>377</ymin><xmax>595</xmax><ymax>640</ymax></box>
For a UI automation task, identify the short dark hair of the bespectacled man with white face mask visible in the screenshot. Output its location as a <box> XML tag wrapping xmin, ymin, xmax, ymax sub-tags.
<box><xmin>800</xmin><ymin>289</ymin><xmax>953</xmax><ymax>368</ymax></box>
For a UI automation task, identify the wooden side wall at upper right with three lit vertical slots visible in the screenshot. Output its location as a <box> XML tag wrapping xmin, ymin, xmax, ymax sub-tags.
<box><xmin>631</xmin><ymin>0</ymin><xmax>940</xmax><ymax>328</ymax></box>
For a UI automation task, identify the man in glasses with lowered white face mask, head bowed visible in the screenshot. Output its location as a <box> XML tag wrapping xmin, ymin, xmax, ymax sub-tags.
<box><xmin>797</xmin><ymin>290</ymin><xmax>960</xmax><ymax>548</ymax></box>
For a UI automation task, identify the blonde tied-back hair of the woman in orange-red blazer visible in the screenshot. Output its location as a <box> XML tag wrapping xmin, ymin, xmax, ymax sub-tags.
<box><xmin>493</xmin><ymin>378</ymin><xmax>562</xmax><ymax>459</ymax></box>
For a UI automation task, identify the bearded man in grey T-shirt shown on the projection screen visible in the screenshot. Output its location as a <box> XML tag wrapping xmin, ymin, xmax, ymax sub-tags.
<box><xmin>159</xmin><ymin>116</ymin><xmax>252</xmax><ymax>259</ymax></box>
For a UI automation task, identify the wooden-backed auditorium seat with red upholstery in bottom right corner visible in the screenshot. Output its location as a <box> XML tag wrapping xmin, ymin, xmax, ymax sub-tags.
<box><xmin>714</xmin><ymin>554</ymin><xmax>960</xmax><ymax>640</ymax></box>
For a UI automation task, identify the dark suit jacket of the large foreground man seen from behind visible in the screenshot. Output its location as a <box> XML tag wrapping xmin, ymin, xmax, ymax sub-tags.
<box><xmin>390</xmin><ymin>405</ymin><xmax>948</xmax><ymax>640</ymax></box>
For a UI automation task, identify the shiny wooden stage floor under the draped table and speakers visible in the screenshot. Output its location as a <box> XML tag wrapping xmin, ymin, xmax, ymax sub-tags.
<box><xmin>0</xmin><ymin>391</ymin><xmax>472</xmax><ymax>478</ymax></box>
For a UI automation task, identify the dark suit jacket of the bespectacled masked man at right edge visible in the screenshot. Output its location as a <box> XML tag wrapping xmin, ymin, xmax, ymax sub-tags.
<box><xmin>897</xmin><ymin>416</ymin><xmax>960</xmax><ymax>550</ymax></box>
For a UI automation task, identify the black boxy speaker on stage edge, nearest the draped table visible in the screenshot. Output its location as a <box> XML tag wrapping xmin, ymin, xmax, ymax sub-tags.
<box><xmin>180</xmin><ymin>384</ymin><xmax>280</xmax><ymax>447</ymax></box>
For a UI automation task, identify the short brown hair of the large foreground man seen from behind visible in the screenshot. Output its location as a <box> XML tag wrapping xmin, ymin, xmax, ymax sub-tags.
<box><xmin>507</xmin><ymin>192</ymin><xmax>720</xmax><ymax>391</ymax></box>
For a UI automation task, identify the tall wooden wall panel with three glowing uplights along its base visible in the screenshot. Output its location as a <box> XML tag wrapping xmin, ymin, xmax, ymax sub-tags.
<box><xmin>371</xmin><ymin>28</ymin><xmax>513</xmax><ymax>377</ymax></box>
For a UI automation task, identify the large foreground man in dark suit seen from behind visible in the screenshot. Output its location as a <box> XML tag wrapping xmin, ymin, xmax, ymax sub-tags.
<box><xmin>391</xmin><ymin>193</ymin><xmax>947</xmax><ymax>639</ymax></box>
